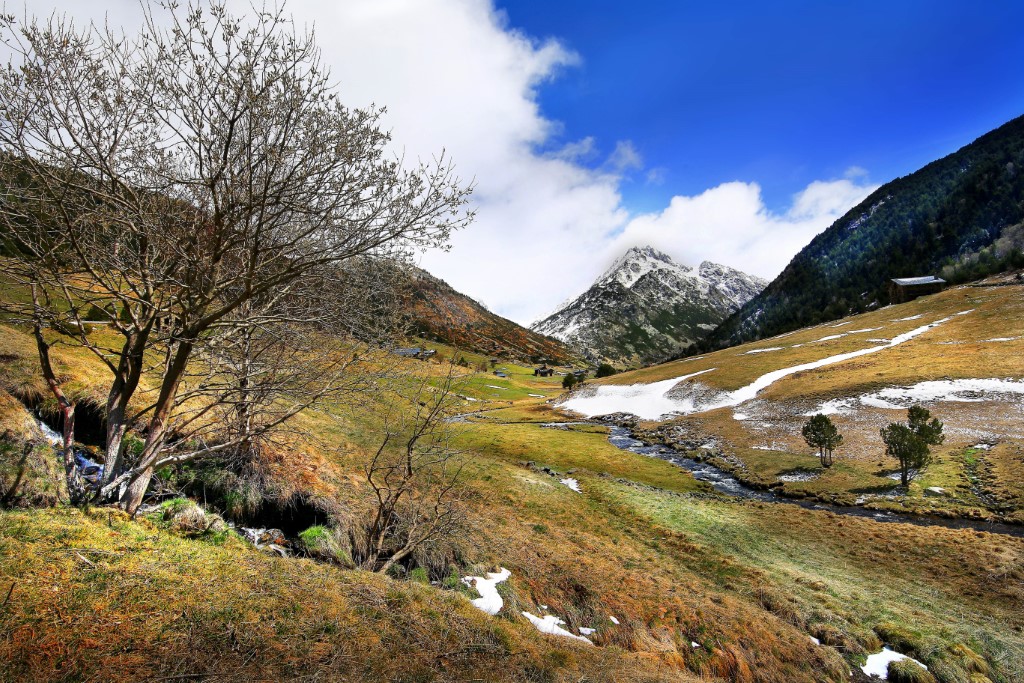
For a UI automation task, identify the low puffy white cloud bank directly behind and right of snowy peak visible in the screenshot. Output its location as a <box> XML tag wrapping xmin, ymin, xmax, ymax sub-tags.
<box><xmin>605</xmin><ymin>175</ymin><xmax>878</xmax><ymax>279</ymax></box>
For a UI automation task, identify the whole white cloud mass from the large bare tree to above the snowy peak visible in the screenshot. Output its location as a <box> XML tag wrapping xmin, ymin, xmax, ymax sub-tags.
<box><xmin>12</xmin><ymin>0</ymin><xmax>869</xmax><ymax>324</ymax></box>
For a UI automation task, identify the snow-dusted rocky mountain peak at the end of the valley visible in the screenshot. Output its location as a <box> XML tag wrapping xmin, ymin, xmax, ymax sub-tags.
<box><xmin>530</xmin><ymin>247</ymin><xmax>767</xmax><ymax>364</ymax></box>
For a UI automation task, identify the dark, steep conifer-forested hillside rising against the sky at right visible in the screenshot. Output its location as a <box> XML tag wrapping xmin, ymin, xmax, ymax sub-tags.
<box><xmin>699</xmin><ymin>117</ymin><xmax>1024</xmax><ymax>350</ymax></box>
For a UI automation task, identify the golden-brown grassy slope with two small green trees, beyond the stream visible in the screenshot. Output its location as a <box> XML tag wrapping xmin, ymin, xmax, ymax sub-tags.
<box><xmin>585</xmin><ymin>281</ymin><xmax>1024</xmax><ymax>520</ymax></box>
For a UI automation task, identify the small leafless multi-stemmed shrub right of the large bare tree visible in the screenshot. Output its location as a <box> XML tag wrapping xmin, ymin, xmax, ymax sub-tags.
<box><xmin>352</xmin><ymin>355</ymin><xmax>462</xmax><ymax>572</ymax></box>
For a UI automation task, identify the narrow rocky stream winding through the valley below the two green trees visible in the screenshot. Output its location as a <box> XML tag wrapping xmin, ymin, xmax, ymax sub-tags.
<box><xmin>594</xmin><ymin>423</ymin><xmax>1024</xmax><ymax>539</ymax></box>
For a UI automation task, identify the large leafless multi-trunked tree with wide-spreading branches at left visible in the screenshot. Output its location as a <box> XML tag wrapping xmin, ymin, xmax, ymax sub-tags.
<box><xmin>0</xmin><ymin>0</ymin><xmax>472</xmax><ymax>511</ymax></box>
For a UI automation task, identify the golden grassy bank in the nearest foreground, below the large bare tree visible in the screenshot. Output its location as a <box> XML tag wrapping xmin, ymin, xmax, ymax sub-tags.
<box><xmin>0</xmin><ymin>510</ymin><xmax>694</xmax><ymax>681</ymax></box>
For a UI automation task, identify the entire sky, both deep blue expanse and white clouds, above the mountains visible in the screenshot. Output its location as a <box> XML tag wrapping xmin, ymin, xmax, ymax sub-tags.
<box><xmin>24</xmin><ymin>0</ymin><xmax>1024</xmax><ymax>325</ymax></box>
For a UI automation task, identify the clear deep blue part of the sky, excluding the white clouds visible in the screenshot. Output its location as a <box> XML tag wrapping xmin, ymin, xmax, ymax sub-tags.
<box><xmin>498</xmin><ymin>0</ymin><xmax>1024</xmax><ymax>211</ymax></box>
